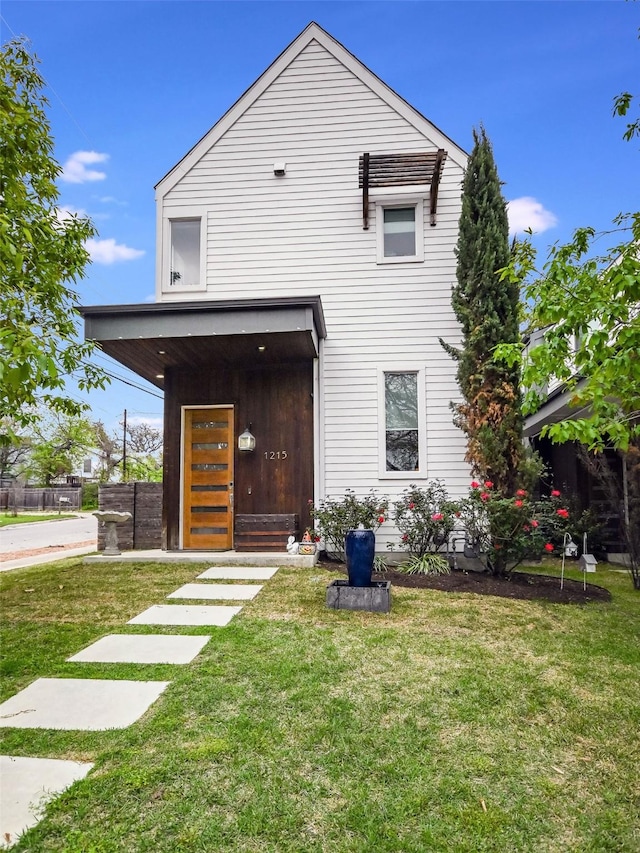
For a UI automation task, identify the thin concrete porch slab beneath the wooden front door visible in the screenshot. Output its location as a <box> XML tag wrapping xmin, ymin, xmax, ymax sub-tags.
<box><xmin>83</xmin><ymin>548</ymin><xmax>318</xmax><ymax>569</ymax></box>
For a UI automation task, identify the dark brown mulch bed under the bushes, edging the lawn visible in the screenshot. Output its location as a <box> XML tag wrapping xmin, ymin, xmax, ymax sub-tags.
<box><xmin>318</xmin><ymin>560</ymin><xmax>611</xmax><ymax>604</ymax></box>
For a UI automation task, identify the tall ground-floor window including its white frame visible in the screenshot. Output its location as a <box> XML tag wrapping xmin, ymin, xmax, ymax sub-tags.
<box><xmin>380</xmin><ymin>370</ymin><xmax>426</xmax><ymax>476</ymax></box>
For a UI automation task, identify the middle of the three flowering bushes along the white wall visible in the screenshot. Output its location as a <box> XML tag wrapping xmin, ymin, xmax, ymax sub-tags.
<box><xmin>393</xmin><ymin>480</ymin><xmax>458</xmax><ymax>557</ymax></box>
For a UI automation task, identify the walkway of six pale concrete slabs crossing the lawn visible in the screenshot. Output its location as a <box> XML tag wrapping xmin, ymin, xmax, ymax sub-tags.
<box><xmin>0</xmin><ymin>566</ymin><xmax>277</xmax><ymax>847</ymax></box>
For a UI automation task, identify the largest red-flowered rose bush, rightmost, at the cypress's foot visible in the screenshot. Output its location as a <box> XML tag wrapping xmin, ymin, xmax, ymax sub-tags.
<box><xmin>460</xmin><ymin>480</ymin><xmax>570</xmax><ymax>576</ymax></box>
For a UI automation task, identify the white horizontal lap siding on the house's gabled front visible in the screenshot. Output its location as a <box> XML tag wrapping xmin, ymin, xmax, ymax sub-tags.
<box><xmin>158</xmin><ymin>36</ymin><xmax>468</xmax><ymax>524</ymax></box>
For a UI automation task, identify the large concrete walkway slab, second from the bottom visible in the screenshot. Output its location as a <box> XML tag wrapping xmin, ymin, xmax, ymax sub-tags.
<box><xmin>0</xmin><ymin>678</ymin><xmax>170</xmax><ymax>732</ymax></box>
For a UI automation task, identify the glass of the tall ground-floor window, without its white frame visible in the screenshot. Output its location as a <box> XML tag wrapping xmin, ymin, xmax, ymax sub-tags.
<box><xmin>384</xmin><ymin>373</ymin><xmax>420</xmax><ymax>471</ymax></box>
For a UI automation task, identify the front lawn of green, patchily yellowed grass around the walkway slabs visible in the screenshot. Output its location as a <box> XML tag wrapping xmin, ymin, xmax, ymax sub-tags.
<box><xmin>0</xmin><ymin>560</ymin><xmax>640</xmax><ymax>853</ymax></box>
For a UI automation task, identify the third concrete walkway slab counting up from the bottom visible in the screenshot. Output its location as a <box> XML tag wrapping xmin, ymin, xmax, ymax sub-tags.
<box><xmin>67</xmin><ymin>634</ymin><xmax>211</xmax><ymax>664</ymax></box>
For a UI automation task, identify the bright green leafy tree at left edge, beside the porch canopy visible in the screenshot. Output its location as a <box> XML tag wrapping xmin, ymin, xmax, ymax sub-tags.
<box><xmin>0</xmin><ymin>35</ymin><xmax>107</xmax><ymax>441</ymax></box>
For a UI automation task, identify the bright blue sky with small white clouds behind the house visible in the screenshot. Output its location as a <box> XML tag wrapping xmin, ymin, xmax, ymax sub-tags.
<box><xmin>0</xmin><ymin>0</ymin><xmax>640</xmax><ymax>427</ymax></box>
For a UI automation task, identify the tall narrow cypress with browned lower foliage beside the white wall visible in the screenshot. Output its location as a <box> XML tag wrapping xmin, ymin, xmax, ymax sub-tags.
<box><xmin>441</xmin><ymin>127</ymin><xmax>523</xmax><ymax>495</ymax></box>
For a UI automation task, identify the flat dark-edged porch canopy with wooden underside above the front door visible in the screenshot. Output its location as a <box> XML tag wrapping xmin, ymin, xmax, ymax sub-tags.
<box><xmin>80</xmin><ymin>296</ymin><xmax>327</xmax><ymax>389</ymax></box>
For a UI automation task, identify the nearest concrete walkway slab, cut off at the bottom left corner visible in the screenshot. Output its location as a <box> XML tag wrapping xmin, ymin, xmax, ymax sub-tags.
<box><xmin>0</xmin><ymin>755</ymin><xmax>93</xmax><ymax>847</ymax></box>
